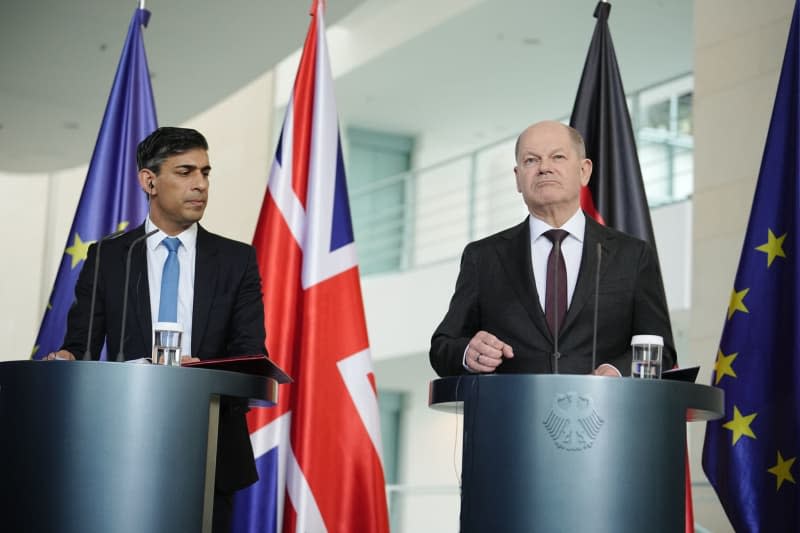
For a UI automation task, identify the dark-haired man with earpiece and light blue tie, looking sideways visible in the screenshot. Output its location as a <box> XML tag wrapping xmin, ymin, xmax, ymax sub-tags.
<box><xmin>47</xmin><ymin>128</ymin><xmax>266</xmax><ymax>532</ymax></box>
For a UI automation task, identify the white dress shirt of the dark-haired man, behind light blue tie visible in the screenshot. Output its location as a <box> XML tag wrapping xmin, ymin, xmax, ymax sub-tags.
<box><xmin>144</xmin><ymin>216</ymin><xmax>197</xmax><ymax>355</ymax></box>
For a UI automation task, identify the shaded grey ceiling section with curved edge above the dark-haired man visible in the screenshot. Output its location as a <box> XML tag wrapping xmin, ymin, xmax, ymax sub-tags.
<box><xmin>0</xmin><ymin>0</ymin><xmax>363</xmax><ymax>172</ymax></box>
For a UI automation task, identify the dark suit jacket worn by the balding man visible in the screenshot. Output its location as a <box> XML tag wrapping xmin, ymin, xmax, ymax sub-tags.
<box><xmin>430</xmin><ymin>217</ymin><xmax>676</xmax><ymax>376</ymax></box>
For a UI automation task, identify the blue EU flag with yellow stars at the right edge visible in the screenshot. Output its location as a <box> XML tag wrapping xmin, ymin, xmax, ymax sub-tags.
<box><xmin>703</xmin><ymin>0</ymin><xmax>800</xmax><ymax>533</ymax></box>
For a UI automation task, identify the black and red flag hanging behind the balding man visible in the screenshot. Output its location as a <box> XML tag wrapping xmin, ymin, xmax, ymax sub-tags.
<box><xmin>570</xmin><ymin>1</ymin><xmax>694</xmax><ymax>533</ymax></box>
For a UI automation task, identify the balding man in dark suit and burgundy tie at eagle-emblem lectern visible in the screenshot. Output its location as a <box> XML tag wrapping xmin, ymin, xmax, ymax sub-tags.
<box><xmin>430</xmin><ymin>121</ymin><xmax>676</xmax><ymax>376</ymax></box>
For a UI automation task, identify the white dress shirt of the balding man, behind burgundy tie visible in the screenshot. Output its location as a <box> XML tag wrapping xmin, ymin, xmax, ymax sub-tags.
<box><xmin>528</xmin><ymin>209</ymin><xmax>586</xmax><ymax>309</ymax></box>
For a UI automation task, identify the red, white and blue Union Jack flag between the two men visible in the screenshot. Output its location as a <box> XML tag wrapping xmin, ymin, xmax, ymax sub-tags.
<box><xmin>233</xmin><ymin>2</ymin><xmax>389</xmax><ymax>533</ymax></box>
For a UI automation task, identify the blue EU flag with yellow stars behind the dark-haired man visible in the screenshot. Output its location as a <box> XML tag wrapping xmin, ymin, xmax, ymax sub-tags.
<box><xmin>32</xmin><ymin>9</ymin><xmax>157</xmax><ymax>359</ymax></box>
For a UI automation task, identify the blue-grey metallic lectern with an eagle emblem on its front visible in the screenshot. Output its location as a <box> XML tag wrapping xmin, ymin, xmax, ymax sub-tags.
<box><xmin>429</xmin><ymin>374</ymin><xmax>723</xmax><ymax>533</ymax></box>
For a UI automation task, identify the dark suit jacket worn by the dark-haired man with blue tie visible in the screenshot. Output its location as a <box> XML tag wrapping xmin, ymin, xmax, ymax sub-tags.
<box><xmin>62</xmin><ymin>226</ymin><xmax>266</xmax><ymax>491</ymax></box>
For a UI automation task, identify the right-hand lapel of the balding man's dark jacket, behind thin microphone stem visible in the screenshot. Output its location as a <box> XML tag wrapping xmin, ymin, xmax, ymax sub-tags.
<box><xmin>559</xmin><ymin>216</ymin><xmax>617</xmax><ymax>337</ymax></box>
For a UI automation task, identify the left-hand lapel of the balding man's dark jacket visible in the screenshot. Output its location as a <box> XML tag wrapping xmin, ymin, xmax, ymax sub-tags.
<box><xmin>496</xmin><ymin>218</ymin><xmax>552</xmax><ymax>339</ymax></box>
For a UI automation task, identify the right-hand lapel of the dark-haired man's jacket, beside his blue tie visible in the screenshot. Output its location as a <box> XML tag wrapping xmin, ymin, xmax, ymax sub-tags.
<box><xmin>192</xmin><ymin>224</ymin><xmax>219</xmax><ymax>357</ymax></box>
